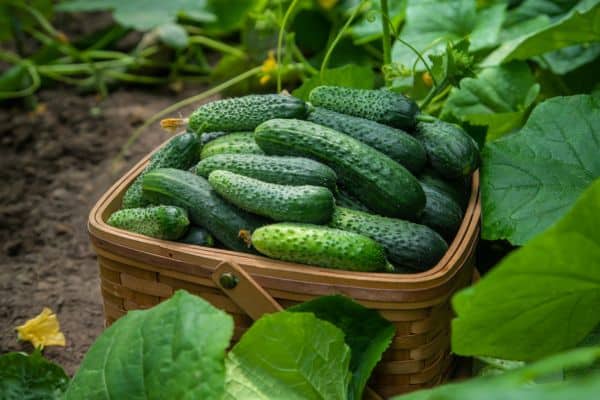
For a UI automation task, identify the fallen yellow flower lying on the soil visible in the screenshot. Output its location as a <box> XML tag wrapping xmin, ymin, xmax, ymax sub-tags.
<box><xmin>17</xmin><ymin>307</ymin><xmax>65</xmax><ymax>349</ymax></box>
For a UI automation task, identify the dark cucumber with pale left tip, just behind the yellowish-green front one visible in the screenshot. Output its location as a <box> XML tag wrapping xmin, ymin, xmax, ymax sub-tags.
<box><xmin>329</xmin><ymin>207</ymin><xmax>448</xmax><ymax>271</ymax></box>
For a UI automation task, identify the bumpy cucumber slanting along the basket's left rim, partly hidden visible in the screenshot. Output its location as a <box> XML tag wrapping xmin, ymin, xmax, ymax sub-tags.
<box><xmin>122</xmin><ymin>133</ymin><xmax>200</xmax><ymax>208</ymax></box>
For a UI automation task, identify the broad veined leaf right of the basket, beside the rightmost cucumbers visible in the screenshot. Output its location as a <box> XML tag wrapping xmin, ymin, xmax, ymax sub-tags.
<box><xmin>481</xmin><ymin>95</ymin><xmax>600</xmax><ymax>245</ymax></box>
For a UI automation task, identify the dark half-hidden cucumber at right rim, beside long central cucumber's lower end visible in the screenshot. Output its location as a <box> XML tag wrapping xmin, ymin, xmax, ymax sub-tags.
<box><xmin>418</xmin><ymin>182</ymin><xmax>463</xmax><ymax>240</ymax></box>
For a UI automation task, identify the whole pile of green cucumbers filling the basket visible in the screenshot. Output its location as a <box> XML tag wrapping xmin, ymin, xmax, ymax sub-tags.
<box><xmin>108</xmin><ymin>86</ymin><xmax>479</xmax><ymax>273</ymax></box>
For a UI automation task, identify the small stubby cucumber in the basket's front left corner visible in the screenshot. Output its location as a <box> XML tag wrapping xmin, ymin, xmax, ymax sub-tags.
<box><xmin>106</xmin><ymin>206</ymin><xmax>190</xmax><ymax>240</ymax></box>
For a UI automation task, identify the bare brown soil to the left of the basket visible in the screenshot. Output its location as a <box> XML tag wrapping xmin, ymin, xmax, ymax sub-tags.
<box><xmin>0</xmin><ymin>89</ymin><xmax>206</xmax><ymax>374</ymax></box>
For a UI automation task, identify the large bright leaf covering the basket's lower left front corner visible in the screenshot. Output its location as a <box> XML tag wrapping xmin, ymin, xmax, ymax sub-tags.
<box><xmin>66</xmin><ymin>291</ymin><xmax>233</xmax><ymax>400</ymax></box>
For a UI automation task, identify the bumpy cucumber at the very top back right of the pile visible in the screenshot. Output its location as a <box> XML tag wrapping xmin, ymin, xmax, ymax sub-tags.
<box><xmin>309</xmin><ymin>86</ymin><xmax>419</xmax><ymax>129</ymax></box>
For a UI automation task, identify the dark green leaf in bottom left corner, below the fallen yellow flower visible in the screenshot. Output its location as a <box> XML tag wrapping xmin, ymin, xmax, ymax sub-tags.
<box><xmin>0</xmin><ymin>350</ymin><xmax>69</xmax><ymax>400</ymax></box>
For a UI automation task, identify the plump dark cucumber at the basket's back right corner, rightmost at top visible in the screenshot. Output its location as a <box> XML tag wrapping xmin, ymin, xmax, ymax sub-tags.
<box><xmin>415</xmin><ymin>119</ymin><xmax>479</xmax><ymax>178</ymax></box>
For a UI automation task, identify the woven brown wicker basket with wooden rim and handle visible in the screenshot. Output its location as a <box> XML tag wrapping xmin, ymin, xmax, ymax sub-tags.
<box><xmin>89</xmin><ymin>141</ymin><xmax>480</xmax><ymax>397</ymax></box>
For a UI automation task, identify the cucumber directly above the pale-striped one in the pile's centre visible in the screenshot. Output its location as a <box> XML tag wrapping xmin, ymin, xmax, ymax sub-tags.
<box><xmin>195</xmin><ymin>154</ymin><xmax>337</xmax><ymax>192</ymax></box>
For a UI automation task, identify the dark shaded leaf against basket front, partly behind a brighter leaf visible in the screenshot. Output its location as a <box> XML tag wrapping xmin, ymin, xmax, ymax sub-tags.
<box><xmin>288</xmin><ymin>296</ymin><xmax>396</xmax><ymax>400</ymax></box>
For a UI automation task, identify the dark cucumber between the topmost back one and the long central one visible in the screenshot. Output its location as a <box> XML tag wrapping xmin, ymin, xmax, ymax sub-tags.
<box><xmin>307</xmin><ymin>107</ymin><xmax>427</xmax><ymax>172</ymax></box>
